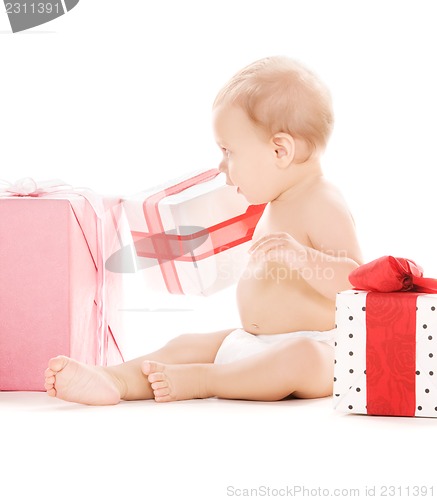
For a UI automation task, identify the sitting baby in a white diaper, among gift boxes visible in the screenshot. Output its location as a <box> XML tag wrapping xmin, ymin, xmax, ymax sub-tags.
<box><xmin>45</xmin><ymin>57</ymin><xmax>362</xmax><ymax>405</ymax></box>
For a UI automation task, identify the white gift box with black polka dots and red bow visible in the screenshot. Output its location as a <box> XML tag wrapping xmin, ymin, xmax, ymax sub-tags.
<box><xmin>334</xmin><ymin>257</ymin><xmax>437</xmax><ymax>417</ymax></box>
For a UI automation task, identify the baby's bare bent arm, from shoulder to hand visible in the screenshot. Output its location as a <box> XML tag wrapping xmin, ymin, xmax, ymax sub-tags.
<box><xmin>251</xmin><ymin>188</ymin><xmax>362</xmax><ymax>300</ymax></box>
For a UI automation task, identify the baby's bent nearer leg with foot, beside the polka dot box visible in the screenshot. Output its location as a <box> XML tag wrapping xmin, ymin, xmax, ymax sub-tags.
<box><xmin>143</xmin><ymin>338</ymin><xmax>334</xmax><ymax>402</ymax></box>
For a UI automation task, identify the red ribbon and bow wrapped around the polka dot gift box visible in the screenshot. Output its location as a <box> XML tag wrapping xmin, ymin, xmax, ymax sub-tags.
<box><xmin>349</xmin><ymin>256</ymin><xmax>437</xmax><ymax>416</ymax></box>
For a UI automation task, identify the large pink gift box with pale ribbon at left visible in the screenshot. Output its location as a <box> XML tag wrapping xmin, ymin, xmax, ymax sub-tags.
<box><xmin>0</xmin><ymin>180</ymin><xmax>123</xmax><ymax>391</ymax></box>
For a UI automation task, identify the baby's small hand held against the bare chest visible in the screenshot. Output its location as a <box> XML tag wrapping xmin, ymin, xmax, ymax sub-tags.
<box><xmin>249</xmin><ymin>233</ymin><xmax>308</xmax><ymax>270</ymax></box>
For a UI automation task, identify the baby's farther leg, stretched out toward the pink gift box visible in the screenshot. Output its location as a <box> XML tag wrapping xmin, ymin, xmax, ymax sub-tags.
<box><xmin>45</xmin><ymin>330</ymin><xmax>232</xmax><ymax>405</ymax></box>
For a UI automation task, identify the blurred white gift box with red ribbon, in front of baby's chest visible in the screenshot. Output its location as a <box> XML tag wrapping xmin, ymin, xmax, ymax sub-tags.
<box><xmin>110</xmin><ymin>169</ymin><xmax>265</xmax><ymax>296</ymax></box>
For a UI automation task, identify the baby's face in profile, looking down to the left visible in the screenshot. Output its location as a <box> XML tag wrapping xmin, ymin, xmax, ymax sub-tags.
<box><xmin>213</xmin><ymin>105</ymin><xmax>281</xmax><ymax>204</ymax></box>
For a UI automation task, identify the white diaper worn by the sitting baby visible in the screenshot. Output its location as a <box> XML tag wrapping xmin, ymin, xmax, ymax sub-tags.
<box><xmin>214</xmin><ymin>328</ymin><xmax>336</xmax><ymax>364</ymax></box>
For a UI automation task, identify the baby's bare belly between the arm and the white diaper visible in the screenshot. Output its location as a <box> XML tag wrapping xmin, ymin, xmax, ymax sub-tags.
<box><xmin>237</xmin><ymin>262</ymin><xmax>335</xmax><ymax>334</ymax></box>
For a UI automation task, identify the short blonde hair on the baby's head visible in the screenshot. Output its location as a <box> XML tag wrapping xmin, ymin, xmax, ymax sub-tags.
<box><xmin>213</xmin><ymin>56</ymin><xmax>334</xmax><ymax>152</ymax></box>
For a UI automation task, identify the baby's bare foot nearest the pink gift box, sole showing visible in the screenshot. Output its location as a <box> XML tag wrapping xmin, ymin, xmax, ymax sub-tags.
<box><xmin>44</xmin><ymin>356</ymin><xmax>120</xmax><ymax>405</ymax></box>
